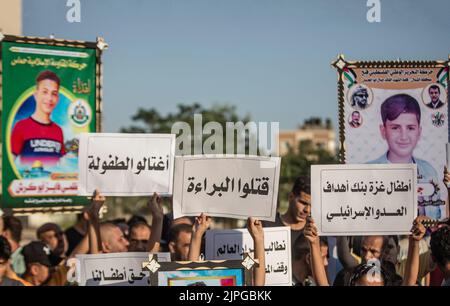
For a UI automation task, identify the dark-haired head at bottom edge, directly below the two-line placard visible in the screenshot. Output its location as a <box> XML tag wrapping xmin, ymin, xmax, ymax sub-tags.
<box><xmin>349</xmin><ymin>260</ymin><xmax>388</xmax><ymax>286</ymax></box>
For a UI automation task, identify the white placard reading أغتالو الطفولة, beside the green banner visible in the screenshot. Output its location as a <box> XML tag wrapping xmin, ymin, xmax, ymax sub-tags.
<box><xmin>78</xmin><ymin>133</ymin><xmax>175</xmax><ymax>196</ymax></box>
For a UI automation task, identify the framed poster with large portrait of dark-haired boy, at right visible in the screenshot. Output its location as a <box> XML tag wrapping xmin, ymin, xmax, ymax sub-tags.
<box><xmin>333</xmin><ymin>56</ymin><xmax>448</xmax><ymax>219</ymax></box>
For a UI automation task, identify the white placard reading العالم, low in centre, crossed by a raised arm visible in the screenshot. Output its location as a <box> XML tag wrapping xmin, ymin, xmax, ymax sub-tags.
<box><xmin>205</xmin><ymin>226</ymin><xmax>292</xmax><ymax>286</ymax></box>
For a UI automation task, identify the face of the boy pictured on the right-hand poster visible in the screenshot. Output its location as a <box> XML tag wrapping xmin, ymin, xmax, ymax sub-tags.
<box><xmin>380</xmin><ymin>114</ymin><xmax>422</xmax><ymax>158</ymax></box>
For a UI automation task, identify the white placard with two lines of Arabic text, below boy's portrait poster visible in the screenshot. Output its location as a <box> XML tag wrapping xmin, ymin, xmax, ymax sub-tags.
<box><xmin>311</xmin><ymin>164</ymin><xmax>416</xmax><ymax>236</ymax></box>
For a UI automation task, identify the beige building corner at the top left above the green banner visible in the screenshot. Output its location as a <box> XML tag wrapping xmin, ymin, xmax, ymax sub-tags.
<box><xmin>0</xmin><ymin>0</ymin><xmax>22</xmax><ymax>35</ymax></box>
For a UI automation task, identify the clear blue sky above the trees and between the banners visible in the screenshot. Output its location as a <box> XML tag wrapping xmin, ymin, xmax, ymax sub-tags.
<box><xmin>23</xmin><ymin>0</ymin><xmax>450</xmax><ymax>132</ymax></box>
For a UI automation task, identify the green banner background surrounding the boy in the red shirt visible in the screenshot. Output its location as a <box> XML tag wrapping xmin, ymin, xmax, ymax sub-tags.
<box><xmin>1</xmin><ymin>42</ymin><xmax>96</xmax><ymax>209</ymax></box>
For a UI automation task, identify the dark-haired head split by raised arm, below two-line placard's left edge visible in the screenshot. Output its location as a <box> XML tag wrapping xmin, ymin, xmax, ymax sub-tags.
<box><xmin>291</xmin><ymin>235</ymin><xmax>329</xmax><ymax>281</ymax></box>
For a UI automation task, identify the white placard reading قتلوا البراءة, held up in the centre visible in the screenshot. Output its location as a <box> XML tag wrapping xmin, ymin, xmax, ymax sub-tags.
<box><xmin>173</xmin><ymin>156</ymin><xmax>280</xmax><ymax>221</ymax></box>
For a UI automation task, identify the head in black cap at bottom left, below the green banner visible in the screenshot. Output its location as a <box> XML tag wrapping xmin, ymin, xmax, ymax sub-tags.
<box><xmin>22</xmin><ymin>241</ymin><xmax>51</xmax><ymax>286</ymax></box>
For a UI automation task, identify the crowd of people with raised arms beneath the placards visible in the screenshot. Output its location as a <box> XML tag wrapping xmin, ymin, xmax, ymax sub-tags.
<box><xmin>0</xmin><ymin>172</ymin><xmax>450</xmax><ymax>286</ymax></box>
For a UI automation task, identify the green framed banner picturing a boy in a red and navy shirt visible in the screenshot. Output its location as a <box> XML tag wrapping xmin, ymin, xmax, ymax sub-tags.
<box><xmin>1</xmin><ymin>39</ymin><xmax>99</xmax><ymax>212</ymax></box>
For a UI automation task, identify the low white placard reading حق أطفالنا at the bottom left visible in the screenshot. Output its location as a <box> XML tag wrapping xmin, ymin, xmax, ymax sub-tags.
<box><xmin>75</xmin><ymin>252</ymin><xmax>170</xmax><ymax>286</ymax></box>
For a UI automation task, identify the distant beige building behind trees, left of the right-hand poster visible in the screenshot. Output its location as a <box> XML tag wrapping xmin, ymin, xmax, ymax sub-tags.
<box><xmin>279</xmin><ymin>118</ymin><xmax>336</xmax><ymax>156</ymax></box>
